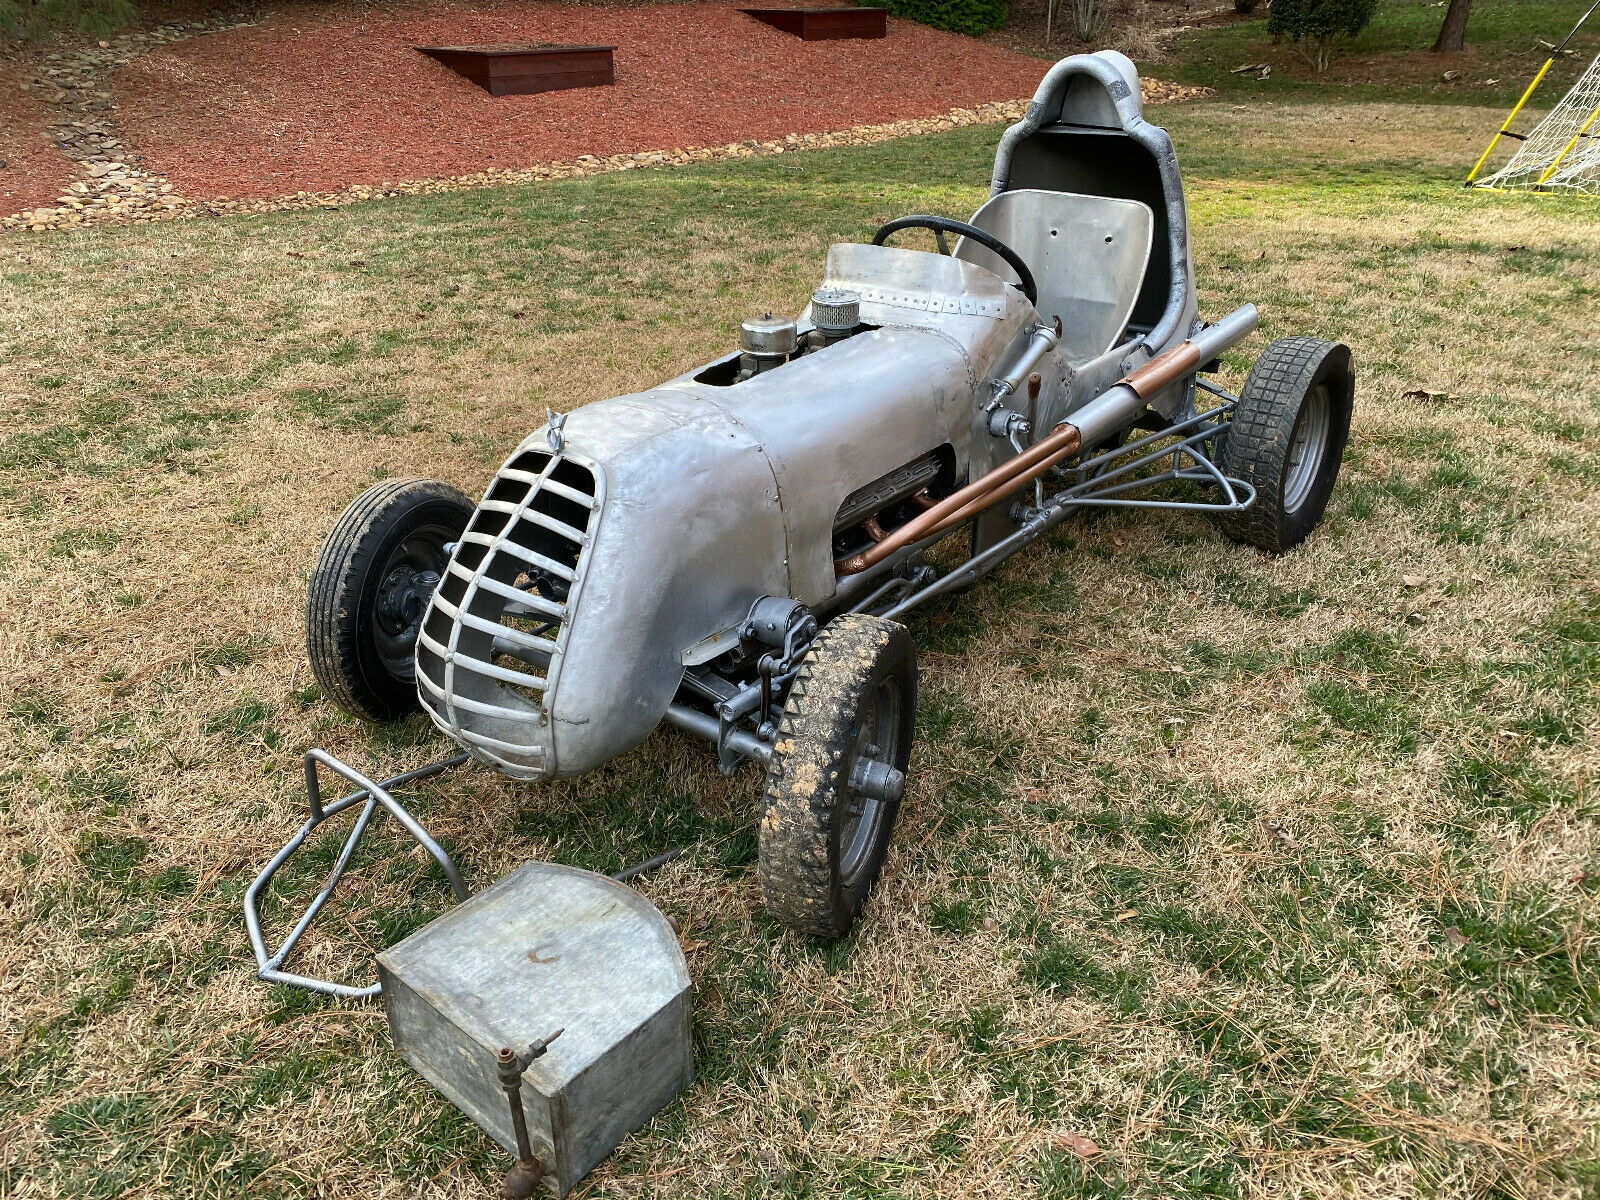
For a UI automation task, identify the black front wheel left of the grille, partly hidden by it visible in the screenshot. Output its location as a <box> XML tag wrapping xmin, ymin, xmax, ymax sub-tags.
<box><xmin>306</xmin><ymin>478</ymin><xmax>474</xmax><ymax>722</ymax></box>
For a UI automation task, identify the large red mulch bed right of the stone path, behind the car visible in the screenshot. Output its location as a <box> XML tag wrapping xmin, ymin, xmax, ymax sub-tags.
<box><xmin>114</xmin><ymin>0</ymin><xmax>1048</xmax><ymax>200</ymax></box>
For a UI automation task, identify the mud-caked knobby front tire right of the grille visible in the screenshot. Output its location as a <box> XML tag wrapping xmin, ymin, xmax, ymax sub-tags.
<box><xmin>758</xmin><ymin>613</ymin><xmax>917</xmax><ymax>938</ymax></box>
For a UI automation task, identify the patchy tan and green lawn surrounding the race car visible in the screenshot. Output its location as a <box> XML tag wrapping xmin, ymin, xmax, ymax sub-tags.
<box><xmin>0</xmin><ymin>99</ymin><xmax>1600</xmax><ymax>1200</ymax></box>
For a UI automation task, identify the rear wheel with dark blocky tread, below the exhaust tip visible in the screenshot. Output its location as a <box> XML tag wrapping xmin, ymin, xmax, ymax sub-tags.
<box><xmin>1218</xmin><ymin>338</ymin><xmax>1355</xmax><ymax>554</ymax></box>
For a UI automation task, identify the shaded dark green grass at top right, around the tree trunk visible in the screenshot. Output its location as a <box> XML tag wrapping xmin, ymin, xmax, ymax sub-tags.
<box><xmin>1154</xmin><ymin>0</ymin><xmax>1600</xmax><ymax>108</ymax></box>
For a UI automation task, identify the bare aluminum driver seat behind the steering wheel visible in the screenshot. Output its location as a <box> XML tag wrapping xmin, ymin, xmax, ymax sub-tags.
<box><xmin>955</xmin><ymin>187</ymin><xmax>1155</xmax><ymax>363</ymax></box>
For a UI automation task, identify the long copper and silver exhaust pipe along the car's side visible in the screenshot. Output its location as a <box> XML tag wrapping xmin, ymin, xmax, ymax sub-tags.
<box><xmin>834</xmin><ymin>304</ymin><xmax>1259</xmax><ymax>576</ymax></box>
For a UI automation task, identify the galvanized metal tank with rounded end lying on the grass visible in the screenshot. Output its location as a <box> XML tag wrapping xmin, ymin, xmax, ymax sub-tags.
<box><xmin>378</xmin><ymin>862</ymin><xmax>694</xmax><ymax>1195</ymax></box>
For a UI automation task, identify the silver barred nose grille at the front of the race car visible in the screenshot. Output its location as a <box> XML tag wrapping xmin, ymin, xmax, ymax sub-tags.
<box><xmin>416</xmin><ymin>450</ymin><xmax>602</xmax><ymax>779</ymax></box>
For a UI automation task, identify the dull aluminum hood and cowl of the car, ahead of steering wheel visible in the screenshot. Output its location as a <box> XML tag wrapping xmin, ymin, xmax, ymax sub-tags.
<box><xmin>418</xmin><ymin>245</ymin><xmax>1035</xmax><ymax>779</ymax></box>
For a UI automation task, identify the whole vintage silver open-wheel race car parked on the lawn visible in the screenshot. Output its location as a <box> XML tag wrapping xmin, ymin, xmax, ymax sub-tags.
<box><xmin>258</xmin><ymin>53</ymin><xmax>1355</xmax><ymax>972</ymax></box>
